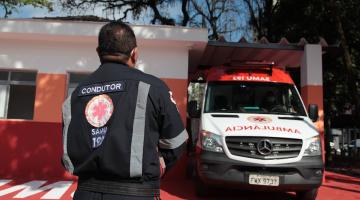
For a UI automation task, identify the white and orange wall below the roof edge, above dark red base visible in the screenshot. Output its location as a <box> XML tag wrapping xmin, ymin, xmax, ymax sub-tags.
<box><xmin>0</xmin><ymin>38</ymin><xmax>188</xmax><ymax>122</ymax></box>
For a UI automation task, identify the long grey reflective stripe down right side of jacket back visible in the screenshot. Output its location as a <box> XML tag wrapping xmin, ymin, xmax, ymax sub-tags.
<box><xmin>130</xmin><ymin>81</ymin><xmax>150</xmax><ymax>177</ymax></box>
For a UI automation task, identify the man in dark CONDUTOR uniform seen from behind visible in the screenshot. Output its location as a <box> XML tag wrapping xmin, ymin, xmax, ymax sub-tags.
<box><xmin>62</xmin><ymin>22</ymin><xmax>188</xmax><ymax>200</ymax></box>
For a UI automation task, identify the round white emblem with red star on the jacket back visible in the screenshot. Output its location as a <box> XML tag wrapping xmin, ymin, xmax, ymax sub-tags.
<box><xmin>85</xmin><ymin>94</ymin><xmax>114</xmax><ymax>128</ymax></box>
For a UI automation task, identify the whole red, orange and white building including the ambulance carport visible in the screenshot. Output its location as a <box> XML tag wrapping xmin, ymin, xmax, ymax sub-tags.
<box><xmin>0</xmin><ymin>19</ymin><xmax>323</xmax><ymax>199</ymax></box>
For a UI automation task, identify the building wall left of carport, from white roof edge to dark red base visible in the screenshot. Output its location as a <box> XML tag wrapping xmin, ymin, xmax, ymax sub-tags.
<box><xmin>0</xmin><ymin>19</ymin><xmax>207</xmax><ymax>183</ymax></box>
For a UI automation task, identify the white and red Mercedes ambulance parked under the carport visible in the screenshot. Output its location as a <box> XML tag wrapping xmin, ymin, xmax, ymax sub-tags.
<box><xmin>188</xmin><ymin>65</ymin><xmax>324</xmax><ymax>199</ymax></box>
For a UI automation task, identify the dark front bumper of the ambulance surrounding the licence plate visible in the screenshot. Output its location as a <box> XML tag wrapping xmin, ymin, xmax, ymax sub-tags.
<box><xmin>197</xmin><ymin>151</ymin><xmax>324</xmax><ymax>191</ymax></box>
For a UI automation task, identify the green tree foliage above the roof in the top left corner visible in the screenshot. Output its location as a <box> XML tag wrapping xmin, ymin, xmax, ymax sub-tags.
<box><xmin>0</xmin><ymin>0</ymin><xmax>53</xmax><ymax>18</ymax></box>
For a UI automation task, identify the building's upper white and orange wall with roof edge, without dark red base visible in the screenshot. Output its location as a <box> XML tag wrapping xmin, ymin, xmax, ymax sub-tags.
<box><xmin>0</xmin><ymin>19</ymin><xmax>207</xmax><ymax>123</ymax></box>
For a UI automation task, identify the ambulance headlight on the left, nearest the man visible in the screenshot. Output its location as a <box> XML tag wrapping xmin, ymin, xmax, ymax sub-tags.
<box><xmin>199</xmin><ymin>131</ymin><xmax>224</xmax><ymax>153</ymax></box>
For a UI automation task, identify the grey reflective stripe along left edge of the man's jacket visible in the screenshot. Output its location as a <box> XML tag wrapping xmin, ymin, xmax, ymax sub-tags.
<box><xmin>62</xmin><ymin>95</ymin><xmax>74</xmax><ymax>173</ymax></box>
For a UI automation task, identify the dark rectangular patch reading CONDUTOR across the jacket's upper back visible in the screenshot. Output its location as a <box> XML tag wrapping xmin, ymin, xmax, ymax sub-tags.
<box><xmin>78</xmin><ymin>81</ymin><xmax>125</xmax><ymax>96</ymax></box>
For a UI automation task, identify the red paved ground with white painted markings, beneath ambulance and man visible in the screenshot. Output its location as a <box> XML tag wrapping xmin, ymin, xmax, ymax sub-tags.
<box><xmin>0</xmin><ymin>172</ymin><xmax>360</xmax><ymax>200</ymax></box>
